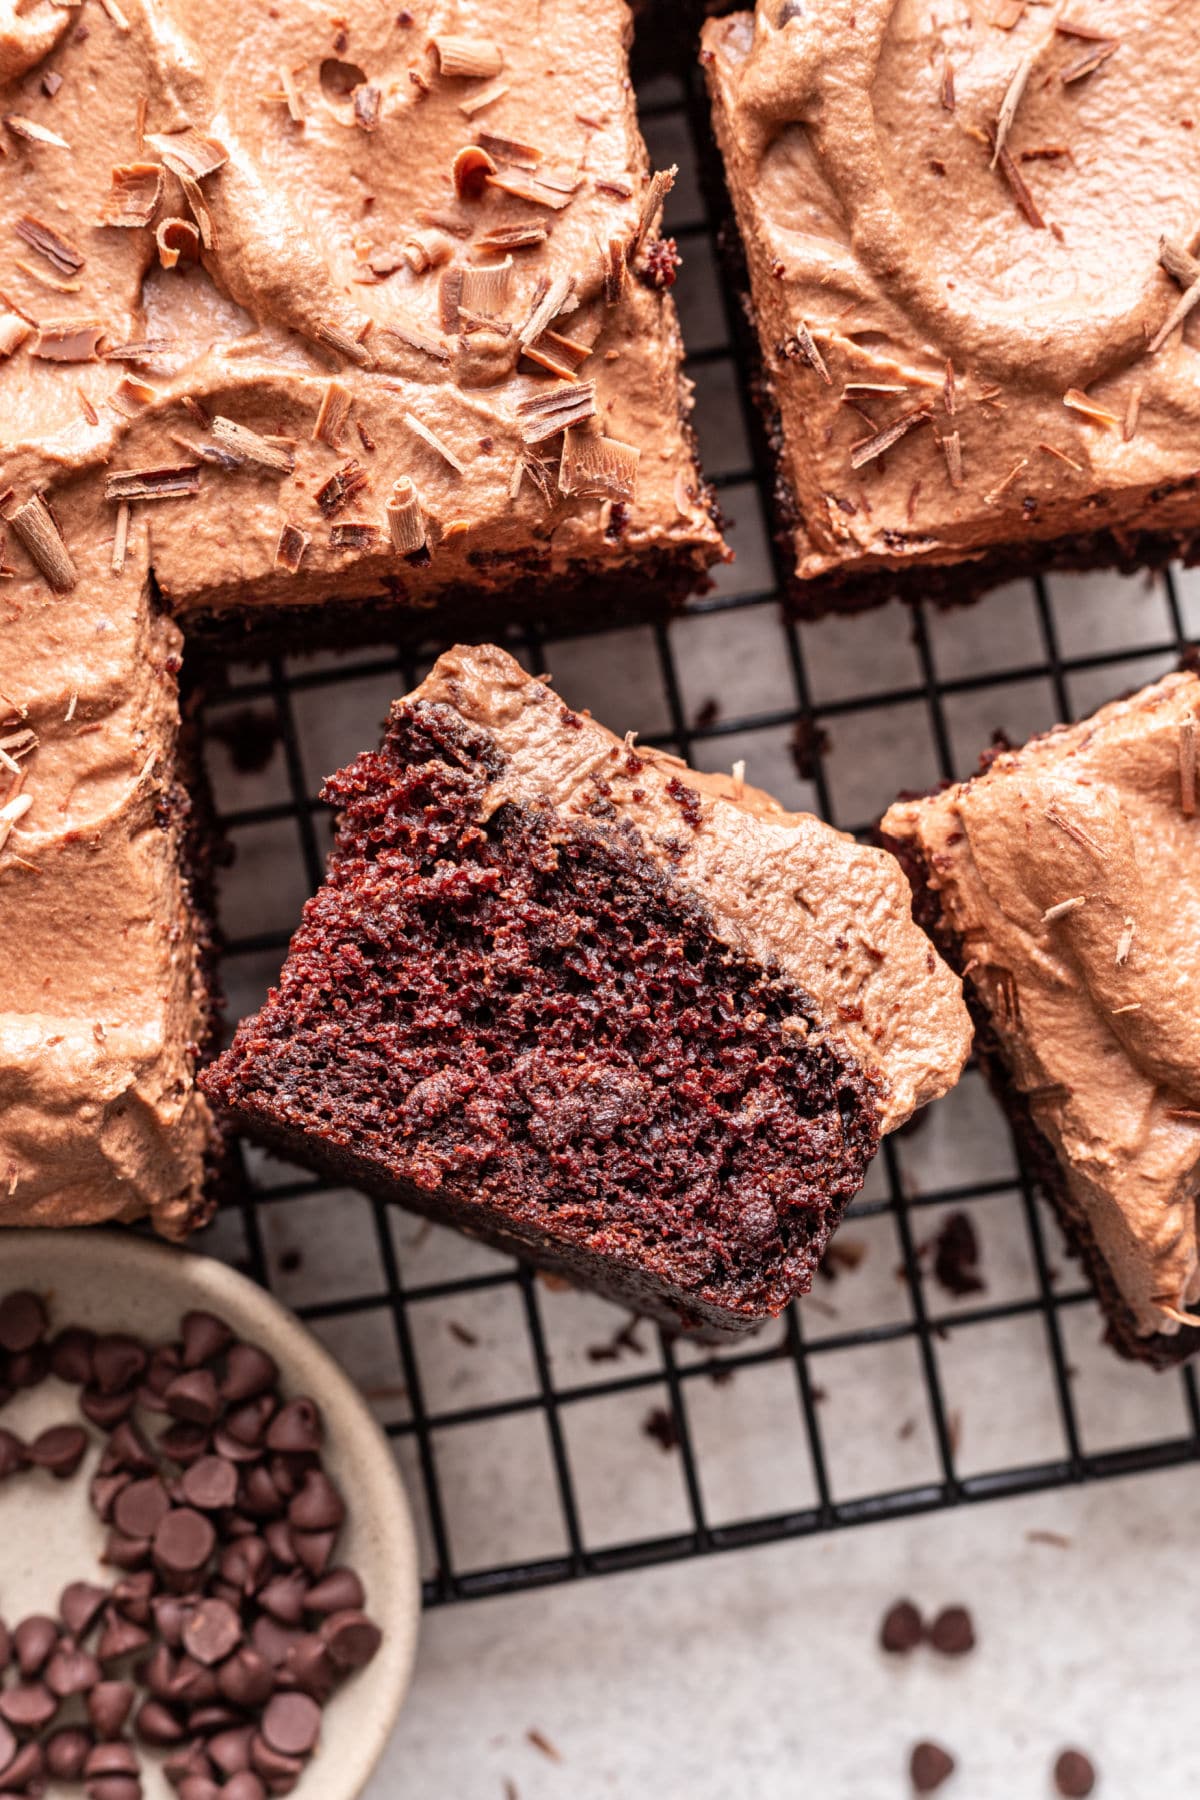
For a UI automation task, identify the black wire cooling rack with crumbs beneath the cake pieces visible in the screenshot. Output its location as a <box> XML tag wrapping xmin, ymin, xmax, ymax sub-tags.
<box><xmin>189</xmin><ymin>45</ymin><xmax>1200</xmax><ymax>1604</ymax></box>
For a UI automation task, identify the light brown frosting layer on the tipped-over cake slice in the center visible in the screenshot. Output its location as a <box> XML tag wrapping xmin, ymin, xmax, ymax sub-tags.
<box><xmin>408</xmin><ymin>644</ymin><xmax>972</xmax><ymax>1130</ymax></box>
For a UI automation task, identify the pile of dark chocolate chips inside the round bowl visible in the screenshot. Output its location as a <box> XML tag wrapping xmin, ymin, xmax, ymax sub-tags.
<box><xmin>0</xmin><ymin>1292</ymin><xmax>380</xmax><ymax>1800</ymax></box>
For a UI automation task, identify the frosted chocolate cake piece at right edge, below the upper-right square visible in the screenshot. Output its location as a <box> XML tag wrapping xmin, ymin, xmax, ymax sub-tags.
<box><xmin>883</xmin><ymin>673</ymin><xmax>1200</xmax><ymax>1364</ymax></box>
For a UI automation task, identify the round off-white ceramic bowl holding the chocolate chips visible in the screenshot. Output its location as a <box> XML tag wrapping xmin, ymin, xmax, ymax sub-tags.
<box><xmin>0</xmin><ymin>1229</ymin><xmax>421</xmax><ymax>1800</ymax></box>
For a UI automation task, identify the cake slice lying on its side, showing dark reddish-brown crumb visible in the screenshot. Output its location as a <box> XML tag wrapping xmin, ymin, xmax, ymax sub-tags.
<box><xmin>203</xmin><ymin>646</ymin><xmax>970</xmax><ymax>1330</ymax></box>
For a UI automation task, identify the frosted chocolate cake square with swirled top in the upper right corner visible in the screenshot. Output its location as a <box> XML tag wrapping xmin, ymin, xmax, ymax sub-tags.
<box><xmin>703</xmin><ymin>0</ymin><xmax>1200</xmax><ymax>616</ymax></box>
